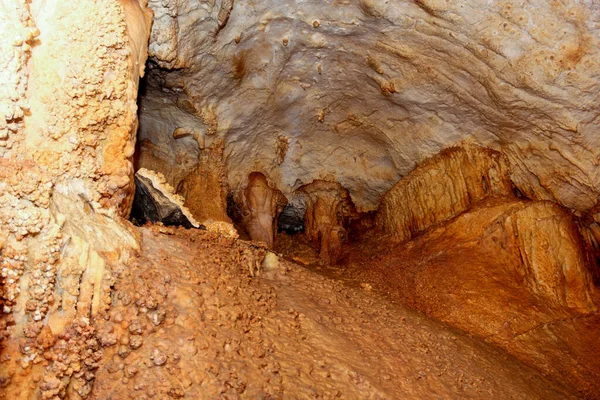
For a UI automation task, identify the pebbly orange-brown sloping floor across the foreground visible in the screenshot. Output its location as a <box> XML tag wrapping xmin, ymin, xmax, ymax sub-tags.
<box><xmin>92</xmin><ymin>226</ymin><xmax>575</xmax><ymax>399</ymax></box>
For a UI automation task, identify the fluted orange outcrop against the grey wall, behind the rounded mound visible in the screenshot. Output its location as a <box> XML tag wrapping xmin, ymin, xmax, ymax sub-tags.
<box><xmin>376</xmin><ymin>146</ymin><xmax>512</xmax><ymax>240</ymax></box>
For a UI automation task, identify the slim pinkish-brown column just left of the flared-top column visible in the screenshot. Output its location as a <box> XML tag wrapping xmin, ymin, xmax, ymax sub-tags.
<box><xmin>241</xmin><ymin>172</ymin><xmax>287</xmax><ymax>249</ymax></box>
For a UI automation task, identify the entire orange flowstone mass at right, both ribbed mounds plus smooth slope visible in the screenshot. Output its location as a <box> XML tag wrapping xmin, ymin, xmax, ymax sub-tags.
<box><xmin>343</xmin><ymin>146</ymin><xmax>600</xmax><ymax>398</ymax></box>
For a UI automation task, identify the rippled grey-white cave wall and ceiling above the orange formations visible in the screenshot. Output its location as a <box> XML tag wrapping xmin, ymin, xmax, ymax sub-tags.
<box><xmin>142</xmin><ymin>0</ymin><xmax>600</xmax><ymax>216</ymax></box>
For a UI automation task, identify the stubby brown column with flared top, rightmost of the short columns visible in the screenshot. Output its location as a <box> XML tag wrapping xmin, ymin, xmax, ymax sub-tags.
<box><xmin>298</xmin><ymin>180</ymin><xmax>356</xmax><ymax>264</ymax></box>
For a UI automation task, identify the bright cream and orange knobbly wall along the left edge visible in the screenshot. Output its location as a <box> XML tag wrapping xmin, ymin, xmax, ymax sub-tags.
<box><xmin>0</xmin><ymin>0</ymin><xmax>151</xmax><ymax>398</ymax></box>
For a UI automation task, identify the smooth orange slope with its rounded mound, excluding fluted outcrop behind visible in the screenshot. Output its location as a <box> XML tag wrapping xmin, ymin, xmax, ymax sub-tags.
<box><xmin>344</xmin><ymin>198</ymin><xmax>600</xmax><ymax>398</ymax></box>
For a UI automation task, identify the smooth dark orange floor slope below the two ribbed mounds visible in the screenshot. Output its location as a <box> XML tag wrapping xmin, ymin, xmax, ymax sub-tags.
<box><xmin>278</xmin><ymin>199</ymin><xmax>600</xmax><ymax>398</ymax></box>
